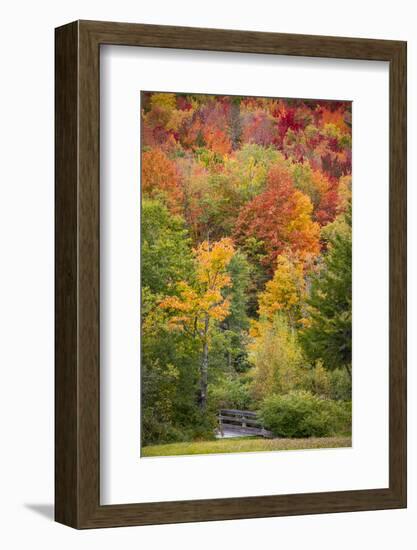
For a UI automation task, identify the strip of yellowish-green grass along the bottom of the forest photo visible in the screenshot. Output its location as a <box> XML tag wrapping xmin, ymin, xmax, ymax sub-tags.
<box><xmin>142</xmin><ymin>437</ymin><xmax>352</xmax><ymax>457</ymax></box>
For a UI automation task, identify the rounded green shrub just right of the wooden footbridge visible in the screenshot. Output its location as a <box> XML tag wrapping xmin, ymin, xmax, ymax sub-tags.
<box><xmin>260</xmin><ymin>391</ymin><xmax>351</xmax><ymax>437</ymax></box>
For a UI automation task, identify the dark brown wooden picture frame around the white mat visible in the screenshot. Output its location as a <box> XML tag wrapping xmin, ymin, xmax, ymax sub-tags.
<box><xmin>55</xmin><ymin>21</ymin><xmax>407</xmax><ymax>528</ymax></box>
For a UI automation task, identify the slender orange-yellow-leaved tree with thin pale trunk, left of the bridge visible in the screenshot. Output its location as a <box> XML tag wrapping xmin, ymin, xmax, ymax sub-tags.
<box><xmin>160</xmin><ymin>238</ymin><xmax>235</xmax><ymax>410</ymax></box>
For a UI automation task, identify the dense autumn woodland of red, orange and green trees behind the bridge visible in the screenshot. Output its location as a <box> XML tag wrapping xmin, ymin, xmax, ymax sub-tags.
<box><xmin>141</xmin><ymin>92</ymin><xmax>352</xmax><ymax>445</ymax></box>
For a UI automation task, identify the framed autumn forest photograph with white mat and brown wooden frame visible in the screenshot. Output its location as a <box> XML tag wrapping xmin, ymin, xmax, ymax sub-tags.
<box><xmin>55</xmin><ymin>21</ymin><xmax>407</xmax><ymax>528</ymax></box>
